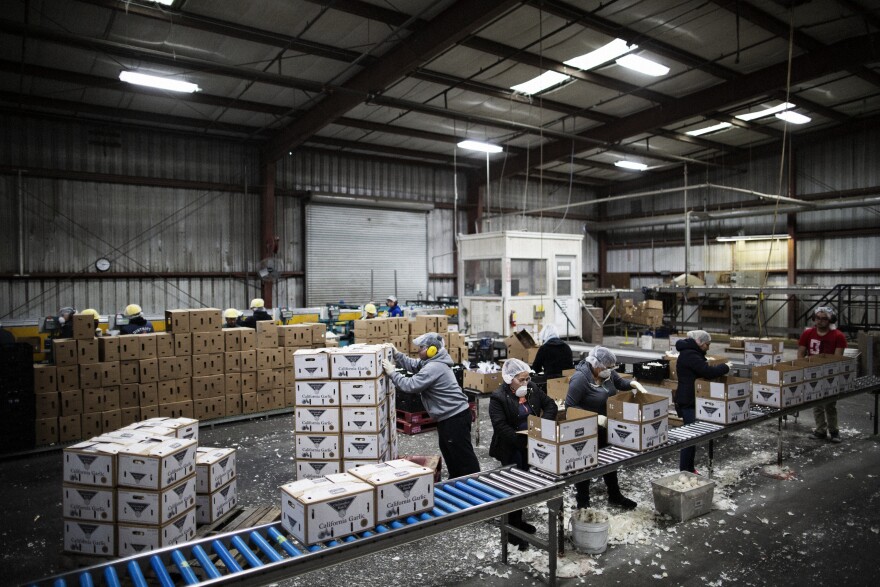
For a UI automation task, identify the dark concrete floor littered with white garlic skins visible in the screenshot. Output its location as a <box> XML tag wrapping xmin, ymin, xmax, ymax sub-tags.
<box><xmin>0</xmin><ymin>338</ymin><xmax>880</xmax><ymax>587</ymax></box>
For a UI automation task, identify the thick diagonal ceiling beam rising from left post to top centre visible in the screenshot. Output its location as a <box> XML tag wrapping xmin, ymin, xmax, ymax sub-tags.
<box><xmin>264</xmin><ymin>0</ymin><xmax>519</xmax><ymax>160</ymax></box>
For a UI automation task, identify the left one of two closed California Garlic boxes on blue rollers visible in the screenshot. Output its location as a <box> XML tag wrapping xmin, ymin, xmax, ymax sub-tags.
<box><xmin>281</xmin><ymin>481</ymin><xmax>376</xmax><ymax>544</ymax></box>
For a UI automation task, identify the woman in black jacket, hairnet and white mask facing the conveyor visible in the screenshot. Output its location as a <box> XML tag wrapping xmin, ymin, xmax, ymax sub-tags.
<box><xmin>489</xmin><ymin>359</ymin><xmax>557</xmax><ymax>550</ymax></box>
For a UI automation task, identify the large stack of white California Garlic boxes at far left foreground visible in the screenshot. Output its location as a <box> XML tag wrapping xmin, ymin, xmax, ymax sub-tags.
<box><xmin>62</xmin><ymin>418</ymin><xmax>198</xmax><ymax>556</ymax></box>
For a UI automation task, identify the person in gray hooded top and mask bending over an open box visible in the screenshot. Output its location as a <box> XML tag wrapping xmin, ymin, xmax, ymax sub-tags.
<box><xmin>565</xmin><ymin>346</ymin><xmax>645</xmax><ymax>510</ymax></box>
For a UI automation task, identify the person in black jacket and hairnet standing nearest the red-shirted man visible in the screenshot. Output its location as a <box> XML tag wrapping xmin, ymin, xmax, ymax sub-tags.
<box><xmin>675</xmin><ymin>330</ymin><xmax>730</xmax><ymax>473</ymax></box>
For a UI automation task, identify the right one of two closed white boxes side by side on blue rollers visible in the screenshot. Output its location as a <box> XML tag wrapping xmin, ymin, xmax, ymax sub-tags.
<box><xmin>348</xmin><ymin>460</ymin><xmax>434</xmax><ymax>524</ymax></box>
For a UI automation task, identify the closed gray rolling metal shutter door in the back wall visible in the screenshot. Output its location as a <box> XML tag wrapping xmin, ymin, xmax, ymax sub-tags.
<box><xmin>306</xmin><ymin>204</ymin><xmax>428</xmax><ymax>307</ymax></box>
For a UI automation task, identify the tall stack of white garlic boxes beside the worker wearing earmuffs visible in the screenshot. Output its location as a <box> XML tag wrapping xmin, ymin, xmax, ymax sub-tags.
<box><xmin>293</xmin><ymin>344</ymin><xmax>398</xmax><ymax>479</ymax></box>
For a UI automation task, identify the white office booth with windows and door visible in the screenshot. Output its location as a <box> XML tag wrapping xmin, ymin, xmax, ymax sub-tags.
<box><xmin>458</xmin><ymin>231</ymin><xmax>584</xmax><ymax>337</ymax></box>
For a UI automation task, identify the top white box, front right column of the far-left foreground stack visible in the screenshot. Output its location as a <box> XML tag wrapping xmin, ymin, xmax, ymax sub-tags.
<box><xmin>116</xmin><ymin>438</ymin><xmax>198</xmax><ymax>490</ymax></box>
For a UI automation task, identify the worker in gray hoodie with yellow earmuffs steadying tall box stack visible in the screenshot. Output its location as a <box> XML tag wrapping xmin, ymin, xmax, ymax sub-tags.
<box><xmin>382</xmin><ymin>332</ymin><xmax>480</xmax><ymax>479</ymax></box>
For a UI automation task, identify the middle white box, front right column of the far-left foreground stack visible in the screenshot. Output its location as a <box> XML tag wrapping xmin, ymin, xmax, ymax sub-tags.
<box><xmin>116</xmin><ymin>475</ymin><xmax>196</xmax><ymax>526</ymax></box>
